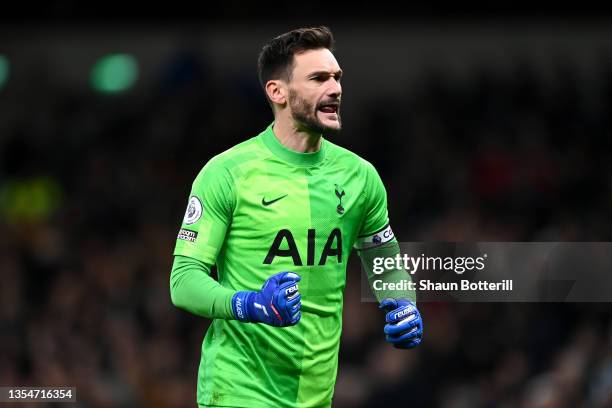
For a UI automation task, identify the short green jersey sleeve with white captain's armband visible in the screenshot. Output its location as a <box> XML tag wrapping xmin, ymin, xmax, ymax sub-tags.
<box><xmin>355</xmin><ymin>163</ymin><xmax>394</xmax><ymax>250</ymax></box>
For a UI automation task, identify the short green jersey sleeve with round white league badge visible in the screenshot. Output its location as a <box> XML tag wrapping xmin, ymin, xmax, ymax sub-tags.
<box><xmin>174</xmin><ymin>159</ymin><xmax>236</xmax><ymax>264</ymax></box>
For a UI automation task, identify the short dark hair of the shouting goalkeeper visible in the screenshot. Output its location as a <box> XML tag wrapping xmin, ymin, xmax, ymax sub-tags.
<box><xmin>257</xmin><ymin>26</ymin><xmax>334</xmax><ymax>89</ymax></box>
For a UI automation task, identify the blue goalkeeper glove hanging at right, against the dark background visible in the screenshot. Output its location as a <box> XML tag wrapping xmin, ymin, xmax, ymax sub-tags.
<box><xmin>379</xmin><ymin>298</ymin><xmax>423</xmax><ymax>349</ymax></box>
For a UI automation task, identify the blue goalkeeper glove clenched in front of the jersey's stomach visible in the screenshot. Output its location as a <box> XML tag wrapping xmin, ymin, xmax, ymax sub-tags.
<box><xmin>232</xmin><ymin>272</ymin><xmax>302</xmax><ymax>327</ymax></box>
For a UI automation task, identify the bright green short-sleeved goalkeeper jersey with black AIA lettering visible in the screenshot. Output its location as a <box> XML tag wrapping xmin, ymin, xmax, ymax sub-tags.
<box><xmin>174</xmin><ymin>124</ymin><xmax>393</xmax><ymax>408</ymax></box>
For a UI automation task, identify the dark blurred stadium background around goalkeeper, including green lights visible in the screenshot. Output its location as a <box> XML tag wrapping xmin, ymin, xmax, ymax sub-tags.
<box><xmin>0</xmin><ymin>7</ymin><xmax>612</xmax><ymax>408</ymax></box>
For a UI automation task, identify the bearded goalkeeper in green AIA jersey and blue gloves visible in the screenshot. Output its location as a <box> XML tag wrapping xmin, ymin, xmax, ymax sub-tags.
<box><xmin>171</xmin><ymin>27</ymin><xmax>422</xmax><ymax>408</ymax></box>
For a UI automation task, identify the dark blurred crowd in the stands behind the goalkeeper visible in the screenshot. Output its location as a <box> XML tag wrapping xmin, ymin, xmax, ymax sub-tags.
<box><xmin>0</xmin><ymin>43</ymin><xmax>612</xmax><ymax>408</ymax></box>
